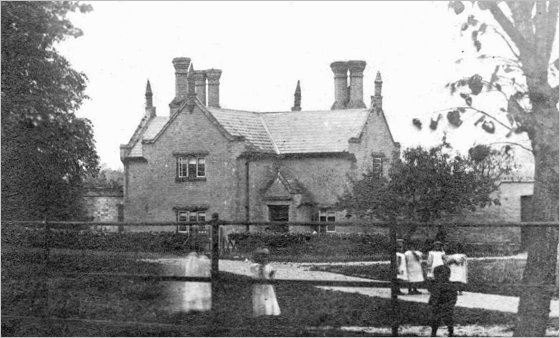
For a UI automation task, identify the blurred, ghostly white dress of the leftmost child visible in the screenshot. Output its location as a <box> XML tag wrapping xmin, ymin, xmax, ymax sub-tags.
<box><xmin>181</xmin><ymin>252</ymin><xmax>212</xmax><ymax>312</ymax></box>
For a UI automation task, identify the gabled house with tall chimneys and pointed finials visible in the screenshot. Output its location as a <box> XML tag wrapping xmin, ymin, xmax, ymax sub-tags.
<box><xmin>120</xmin><ymin>57</ymin><xmax>400</xmax><ymax>232</ymax></box>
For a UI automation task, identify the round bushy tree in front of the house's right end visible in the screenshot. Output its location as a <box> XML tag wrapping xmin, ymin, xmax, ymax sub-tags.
<box><xmin>338</xmin><ymin>144</ymin><xmax>512</xmax><ymax>240</ymax></box>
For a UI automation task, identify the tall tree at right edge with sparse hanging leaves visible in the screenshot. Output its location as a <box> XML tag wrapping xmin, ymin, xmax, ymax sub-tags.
<box><xmin>428</xmin><ymin>1</ymin><xmax>559</xmax><ymax>336</ymax></box>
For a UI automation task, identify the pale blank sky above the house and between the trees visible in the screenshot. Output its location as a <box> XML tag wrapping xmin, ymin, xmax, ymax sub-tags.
<box><xmin>58</xmin><ymin>1</ymin><xmax>552</xmax><ymax>172</ymax></box>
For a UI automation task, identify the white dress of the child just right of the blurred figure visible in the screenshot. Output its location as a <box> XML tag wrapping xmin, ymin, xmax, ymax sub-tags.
<box><xmin>251</xmin><ymin>264</ymin><xmax>280</xmax><ymax>316</ymax></box>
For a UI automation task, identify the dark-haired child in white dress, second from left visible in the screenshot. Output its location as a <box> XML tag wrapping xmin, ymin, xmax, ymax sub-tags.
<box><xmin>251</xmin><ymin>249</ymin><xmax>280</xmax><ymax>317</ymax></box>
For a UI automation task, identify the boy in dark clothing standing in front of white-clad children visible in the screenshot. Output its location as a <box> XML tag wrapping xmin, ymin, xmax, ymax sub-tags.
<box><xmin>428</xmin><ymin>265</ymin><xmax>457</xmax><ymax>337</ymax></box>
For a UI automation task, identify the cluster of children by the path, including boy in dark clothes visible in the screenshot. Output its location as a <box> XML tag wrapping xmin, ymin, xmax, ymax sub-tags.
<box><xmin>397</xmin><ymin>241</ymin><xmax>467</xmax><ymax>336</ymax></box>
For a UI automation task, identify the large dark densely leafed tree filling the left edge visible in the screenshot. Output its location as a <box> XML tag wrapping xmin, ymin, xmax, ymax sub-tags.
<box><xmin>1</xmin><ymin>1</ymin><xmax>98</xmax><ymax>220</ymax></box>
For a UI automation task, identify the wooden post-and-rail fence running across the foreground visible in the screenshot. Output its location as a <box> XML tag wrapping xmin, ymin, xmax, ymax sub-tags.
<box><xmin>2</xmin><ymin>215</ymin><xmax>558</xmax><ymax>336</ymax></box>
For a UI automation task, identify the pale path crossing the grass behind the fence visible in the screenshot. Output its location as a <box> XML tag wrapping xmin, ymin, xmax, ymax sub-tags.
<box><xmin>143</xmin><ymin>258</ymin><xmax>559</xmax><ymax>318</ymax></box>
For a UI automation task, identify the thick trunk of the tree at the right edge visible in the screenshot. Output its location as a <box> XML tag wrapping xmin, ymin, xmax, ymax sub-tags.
<box><xmin>514</xmin><ymin>109</ymin><xmax>559</xmax><ymax>337</ymax></box>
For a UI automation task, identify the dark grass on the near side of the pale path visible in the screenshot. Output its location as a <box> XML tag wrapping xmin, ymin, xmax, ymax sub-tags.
<box><xmin>2</xmin><ymin>251</ymin><xmax>558</xmax><ymax>336</ymax></box>
